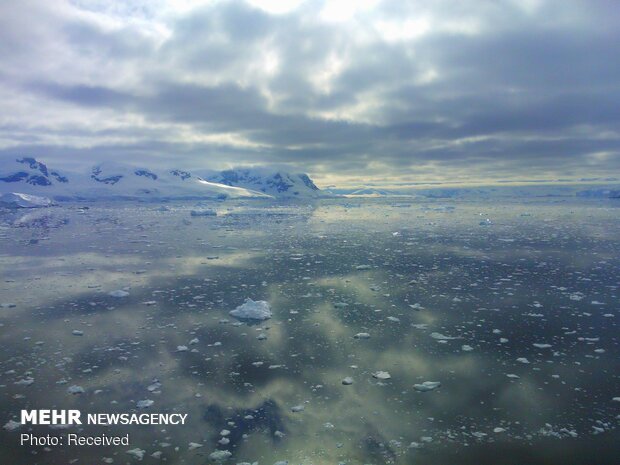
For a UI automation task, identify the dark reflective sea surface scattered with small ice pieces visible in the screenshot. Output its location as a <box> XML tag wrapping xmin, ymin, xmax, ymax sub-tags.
<box><xmin>0</xmin><ymin>200</ymin><xmax>620</xmax><ymax>465</ymax></box>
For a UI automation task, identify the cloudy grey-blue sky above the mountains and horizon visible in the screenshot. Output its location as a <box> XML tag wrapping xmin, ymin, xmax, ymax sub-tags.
<box><xmin>0</xmin><ymin>0</ymin><xmax>620</xmax><ymax>185</ymax></box>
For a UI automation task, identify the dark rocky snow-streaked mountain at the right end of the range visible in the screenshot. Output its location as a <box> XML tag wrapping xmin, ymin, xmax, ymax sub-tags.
<box><xmin>205</xmin><ymin>168</ymin><xmax>321</xmax><ymax>198</ymax></box>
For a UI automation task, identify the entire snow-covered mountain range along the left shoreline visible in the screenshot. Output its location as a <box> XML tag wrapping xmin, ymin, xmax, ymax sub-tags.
<box><xmin>0</xmin><ymin>157</ymin><xmax>319</xmax><ymax>200</ymax></box>
